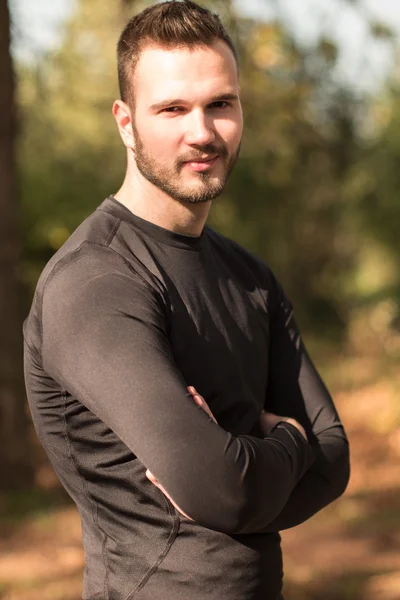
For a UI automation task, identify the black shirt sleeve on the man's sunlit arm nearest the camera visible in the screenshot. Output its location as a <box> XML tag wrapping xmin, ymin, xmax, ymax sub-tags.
<box><xmin>42</xmin><ymin>247</ymin><xmax>314</xmax><ymax>534</ymax></box>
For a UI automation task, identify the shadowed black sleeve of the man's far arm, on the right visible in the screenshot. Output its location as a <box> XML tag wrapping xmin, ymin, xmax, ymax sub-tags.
<box><xmin>264</xmin><ymin>272</ymin><xmax>350</xmax><ymax>531</ymax></box>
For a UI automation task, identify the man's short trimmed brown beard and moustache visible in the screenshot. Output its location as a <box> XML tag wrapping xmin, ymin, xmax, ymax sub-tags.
<box><xmin>132</xmin><ymin>123</ymin><xmax>241</xmax><ymax>204</ymax></box>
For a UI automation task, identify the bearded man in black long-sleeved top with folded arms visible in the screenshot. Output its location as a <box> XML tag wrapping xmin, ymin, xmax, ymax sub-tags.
<box><xmin>24</xmin><ymin>0</ymin><xmax>349</xmax><ymax>600</ymax></box>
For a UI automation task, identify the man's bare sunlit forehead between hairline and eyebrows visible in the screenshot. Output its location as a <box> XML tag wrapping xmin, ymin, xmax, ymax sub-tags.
<box><xmin>133</xmin><ymin>40</ymin><xmax>239</xmax><ymax>104</ymax></box>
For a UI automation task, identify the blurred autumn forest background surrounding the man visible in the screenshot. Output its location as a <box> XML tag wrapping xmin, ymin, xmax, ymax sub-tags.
<box><xmin>0</xmin><ymin>0</ymin><xmax>400</xmax><ymax>600</ymax></box>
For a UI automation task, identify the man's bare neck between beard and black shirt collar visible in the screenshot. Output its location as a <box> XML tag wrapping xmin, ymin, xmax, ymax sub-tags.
<box><xmin>114</xmin><ymin>156</ymin><xmax>211</xmax><ymax>236</ymax></box>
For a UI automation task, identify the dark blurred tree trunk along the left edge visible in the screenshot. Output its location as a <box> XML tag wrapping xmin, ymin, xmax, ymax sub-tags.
<box><xmin>0</xmin><ymin>0</ymin><xmax>32</xmax><ymax>490</ymax></box>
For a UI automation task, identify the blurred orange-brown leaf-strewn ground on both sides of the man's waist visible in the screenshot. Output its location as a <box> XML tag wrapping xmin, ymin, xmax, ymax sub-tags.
<box><xmin>0</xmin><ymin>364</ymin><xmax>400</xmax><ymax>600</ymax></box>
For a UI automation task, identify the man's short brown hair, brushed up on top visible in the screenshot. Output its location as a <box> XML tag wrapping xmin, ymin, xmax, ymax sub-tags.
<box><xmin>117</xmin><ymin>0</ymin><xmax>238</xmax><ymax>102</ymax></box>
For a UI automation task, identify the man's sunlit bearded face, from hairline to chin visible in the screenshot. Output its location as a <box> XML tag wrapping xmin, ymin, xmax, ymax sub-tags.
<box><xmin>132</xmin><ymin>40</ymin><xmax>243</xmax><ymax>203</ymax></box>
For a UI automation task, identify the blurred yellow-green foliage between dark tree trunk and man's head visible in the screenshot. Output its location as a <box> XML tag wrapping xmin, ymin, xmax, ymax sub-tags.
<box><xmin>19</xmin><ymin>0</ymin><xmax>133</xmax><ymax>282</ymax></box>
